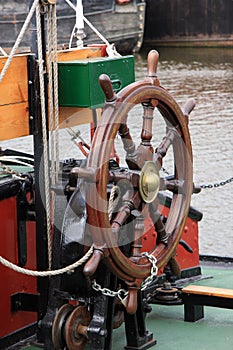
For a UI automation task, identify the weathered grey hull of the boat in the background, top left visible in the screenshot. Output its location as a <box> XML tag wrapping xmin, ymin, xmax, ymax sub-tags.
<box><xmin>0</xmin><ymin>0</ymin><xmax>146</xmax><ymax>53</ymax></box>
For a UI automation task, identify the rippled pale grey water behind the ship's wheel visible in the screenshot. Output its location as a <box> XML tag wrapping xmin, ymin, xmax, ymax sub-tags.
<box><xmin>1</xmin><ymin>48</ymin><xmax>233</xmax><ymax>256</ymax></box>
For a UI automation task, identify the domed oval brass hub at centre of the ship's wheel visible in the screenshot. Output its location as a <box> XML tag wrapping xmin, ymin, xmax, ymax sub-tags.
<box><xmin>139</xmin><ymin>161</ymin><xmax>160</xmax><ymax>203</ymax></box>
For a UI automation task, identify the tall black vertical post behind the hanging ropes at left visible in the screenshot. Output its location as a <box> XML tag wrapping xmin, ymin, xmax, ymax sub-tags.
<box><xmin>28</xmin><ymin>2</ymin><xmax>49</xmax><ymax>340</ymax></box>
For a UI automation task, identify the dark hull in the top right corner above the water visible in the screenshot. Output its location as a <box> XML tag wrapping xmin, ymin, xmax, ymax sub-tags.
<box><xmin>144</xmin><ymin>0</ymin><xmax>233</xmax><ymax>46</ymax></box>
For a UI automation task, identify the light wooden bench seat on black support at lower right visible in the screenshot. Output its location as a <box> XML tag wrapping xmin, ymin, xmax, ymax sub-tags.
<box><xmin>182</xmin><ymin>284</ymin><xmax>233</xmax><ymax>299</ymax></box>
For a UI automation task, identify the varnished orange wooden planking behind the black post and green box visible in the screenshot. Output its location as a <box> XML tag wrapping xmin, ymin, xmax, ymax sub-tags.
<box><xmin>0</xmin><ymin>46</ymin><xmax>104</xmax><ymax>141</ymax></box>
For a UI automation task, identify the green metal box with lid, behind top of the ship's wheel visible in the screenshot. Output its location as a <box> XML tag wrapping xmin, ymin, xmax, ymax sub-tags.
<box><xmin>58</xmin><ymin>55</ymin><xmax>135</xmax><ymax>108</ymax></box>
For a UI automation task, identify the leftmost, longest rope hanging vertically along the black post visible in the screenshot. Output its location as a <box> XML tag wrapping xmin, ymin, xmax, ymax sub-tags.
<box><xmin>36</xmin><ymin>5</ymin><xmax>52</xmax><ymax>268</ymax></box>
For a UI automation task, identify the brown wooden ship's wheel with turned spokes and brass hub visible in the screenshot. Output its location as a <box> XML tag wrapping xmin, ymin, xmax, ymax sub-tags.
<box><xmin>79</xmin><ymin>50</ymin><xmax>194</xmax><ymax>290</ymax></box>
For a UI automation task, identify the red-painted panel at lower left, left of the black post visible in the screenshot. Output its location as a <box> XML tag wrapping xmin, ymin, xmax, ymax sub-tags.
<box><xmin>0</xmin><ymin>197</ymin><xmax>37</xmax><ymax>337</ymax></box>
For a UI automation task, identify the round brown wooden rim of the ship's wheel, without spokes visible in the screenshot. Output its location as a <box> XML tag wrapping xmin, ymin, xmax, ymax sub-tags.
<box><xmin>84</xmin><ymin>51</ymin><xmax>192</xmax><ymax>280</ymax></box>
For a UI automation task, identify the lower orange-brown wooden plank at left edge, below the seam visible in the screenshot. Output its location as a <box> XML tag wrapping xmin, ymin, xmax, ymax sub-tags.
<box><xmin>0</xmin><ymin>102</ymin><xmax>29</xmax><ymax>141</ymax></box>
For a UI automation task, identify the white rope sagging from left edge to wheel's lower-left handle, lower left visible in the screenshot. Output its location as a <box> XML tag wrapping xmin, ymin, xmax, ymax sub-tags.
<box><xmin>0</xmin><ymin>246</ymin><xmax>93</xmax><ymax>277</ymax></box>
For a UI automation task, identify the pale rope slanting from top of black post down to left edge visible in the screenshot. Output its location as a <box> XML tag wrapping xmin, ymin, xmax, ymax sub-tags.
<box><xmin>0</xmin><ymin>0</ymin><xmax>40</xmax><ymax>82</ymax></box>
